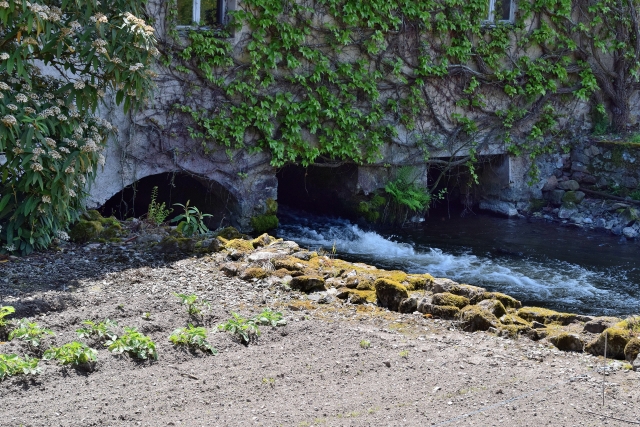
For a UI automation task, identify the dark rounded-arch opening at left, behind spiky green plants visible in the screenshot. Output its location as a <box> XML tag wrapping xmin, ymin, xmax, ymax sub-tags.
<box><xmin>98</xmin><ymin>172</ymin><xmax>240</xmax><ymax>229</ymax></box>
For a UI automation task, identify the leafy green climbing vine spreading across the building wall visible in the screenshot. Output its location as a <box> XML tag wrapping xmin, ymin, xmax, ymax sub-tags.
<box><xmin>163</xmin><ymin>0</ymin><xmax>632</xmax><ymax>179</ymax></box>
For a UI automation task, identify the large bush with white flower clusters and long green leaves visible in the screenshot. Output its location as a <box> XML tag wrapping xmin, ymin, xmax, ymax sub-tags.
<box><xmin>0</xmin><ymin>0</ymin><xmax>158</xmax><ymax>254</ymax></box>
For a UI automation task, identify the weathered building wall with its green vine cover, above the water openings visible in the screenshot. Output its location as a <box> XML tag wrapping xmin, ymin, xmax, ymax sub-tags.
<box><xmin>89</xmin><ymin>0</ymin><xmax>640</xmax><ymax>227</ymax></box>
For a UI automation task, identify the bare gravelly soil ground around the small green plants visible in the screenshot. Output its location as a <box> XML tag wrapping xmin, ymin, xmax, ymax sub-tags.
<box><xmin>0</xmin><ymin>244</ymin><xmax>640</xmax><ymax>427</ymax></box>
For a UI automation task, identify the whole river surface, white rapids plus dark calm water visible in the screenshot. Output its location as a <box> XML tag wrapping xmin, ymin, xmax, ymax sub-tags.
<box><xmin>276</xmin><ymin>212</ymin><xmax>640</xmax><ymax>316</ymax></box>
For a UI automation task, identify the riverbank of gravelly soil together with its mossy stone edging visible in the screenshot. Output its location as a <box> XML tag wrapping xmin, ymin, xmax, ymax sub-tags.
<box><xmin>0</xmin><ymin>212</ymin><xmax>640</xmax><ymax>426</ymax></box>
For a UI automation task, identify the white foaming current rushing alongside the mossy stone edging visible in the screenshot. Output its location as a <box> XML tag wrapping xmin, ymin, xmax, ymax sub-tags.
<box><xmin>277</xmin><ymin>211</ymin><xmax>640</xmax><ymax>316</ymax></box>
